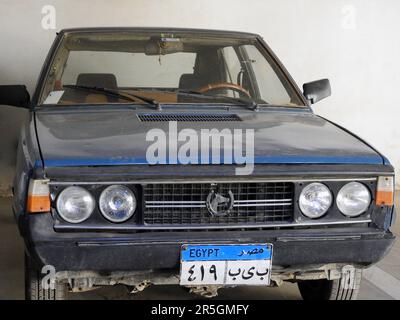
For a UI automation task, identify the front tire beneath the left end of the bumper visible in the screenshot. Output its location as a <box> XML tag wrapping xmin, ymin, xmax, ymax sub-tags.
<box><xmin>25</xmin><ymin>254</ymin><xmax>68</xmax><ymax>300</ymax></box>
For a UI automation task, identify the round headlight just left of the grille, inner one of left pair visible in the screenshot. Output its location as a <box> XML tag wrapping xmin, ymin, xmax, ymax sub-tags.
<box><xmin>99</xmin><ymin>185</ymin><xmax>136</xmax><ymax>222</ymax></box>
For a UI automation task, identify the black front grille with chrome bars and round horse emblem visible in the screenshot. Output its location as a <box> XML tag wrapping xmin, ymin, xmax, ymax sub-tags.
<box><xmin>143</xmin><ymin>182</ymin><xmax>294</xmax><ymax>226</ymax></box>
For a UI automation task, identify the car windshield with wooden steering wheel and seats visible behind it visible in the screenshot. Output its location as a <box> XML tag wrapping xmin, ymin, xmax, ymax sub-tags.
<box><xmin>39</xmin><ymin>32</ymin><xmax>304</xmax><ymax>106</ymax></box>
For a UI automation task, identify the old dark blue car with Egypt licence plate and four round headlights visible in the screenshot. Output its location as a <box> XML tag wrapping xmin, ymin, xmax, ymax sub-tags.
<box><xmin>0</xmin><ymin>28</ymin><xmax>395</xmax><ymax>300</ymax></box>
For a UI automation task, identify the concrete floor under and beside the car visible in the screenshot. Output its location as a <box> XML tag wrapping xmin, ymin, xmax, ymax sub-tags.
<box><xmin>0</xmin><ymin>196</ymin><xmax>400</xmax><ymax>300</ymax></box>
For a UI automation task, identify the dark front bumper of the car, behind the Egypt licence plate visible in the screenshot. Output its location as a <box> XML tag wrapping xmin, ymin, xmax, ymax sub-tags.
<box><xmin>25</xmin><ymin>214</ymin><xmax>395</xmax><ymax>272</ymax></box>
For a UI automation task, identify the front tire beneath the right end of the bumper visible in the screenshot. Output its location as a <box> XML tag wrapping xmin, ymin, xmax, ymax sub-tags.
<box><xmin>297</xmin><ymin>269</ymin><xmax>362</xmax><ymax>300</ymax></box>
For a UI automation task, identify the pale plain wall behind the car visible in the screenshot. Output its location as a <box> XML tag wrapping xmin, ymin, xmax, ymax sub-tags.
<box><xmin>0</xmin><ymin>0</ymin><xmax>400</xmax><ymax>192</ymax></box>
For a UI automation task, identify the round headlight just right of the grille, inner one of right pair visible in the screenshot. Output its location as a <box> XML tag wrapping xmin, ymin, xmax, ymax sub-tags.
<box><xmin>299</xmin><ymin>183</ymin><xmax>332</xmax><ymax>219</ymax></box>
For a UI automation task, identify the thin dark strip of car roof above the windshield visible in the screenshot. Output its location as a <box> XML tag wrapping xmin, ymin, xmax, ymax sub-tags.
<box><xmin>60</xmin><ymin>27</ymin><xmax>260</xmax><ymax>38</ymax></box>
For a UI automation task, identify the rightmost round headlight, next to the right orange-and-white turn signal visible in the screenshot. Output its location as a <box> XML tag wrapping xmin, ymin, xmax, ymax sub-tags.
<box><xmin>336</xmin><ymin>182</ymin><xmax>371</xmax><ymax>217</ymax></box>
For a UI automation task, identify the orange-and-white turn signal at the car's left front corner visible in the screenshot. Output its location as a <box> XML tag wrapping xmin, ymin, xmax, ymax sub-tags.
<box><xmin>27</xmin><ymin>179</ymin><xmax>50</xmax><ymax>213</ymax></box>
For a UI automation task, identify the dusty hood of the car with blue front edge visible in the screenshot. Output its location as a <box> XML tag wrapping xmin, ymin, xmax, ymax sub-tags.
<box><xmin>32</xmin><ymin>108</ymin><xmax>383</xmax><ymax>167</ymax></box>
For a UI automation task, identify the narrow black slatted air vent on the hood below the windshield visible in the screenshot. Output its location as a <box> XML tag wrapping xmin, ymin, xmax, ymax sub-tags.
<box><xmin>138</xmin><ymin>113</ymin><xmax>242</xmax><ymax>122</ymax></box>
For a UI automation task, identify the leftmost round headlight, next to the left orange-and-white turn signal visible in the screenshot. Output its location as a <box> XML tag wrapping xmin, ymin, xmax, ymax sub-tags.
<box><xmin>57</xmin><ymin>187</ymin><xmax>96</xmax><ymax>223</ymax></box>
